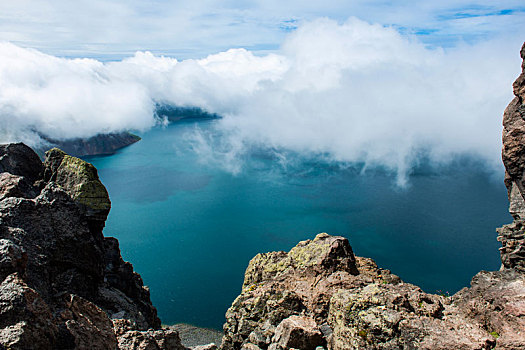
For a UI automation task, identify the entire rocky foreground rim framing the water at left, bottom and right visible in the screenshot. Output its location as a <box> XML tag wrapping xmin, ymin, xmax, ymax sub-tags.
<box><xmin>0</xmin><ymin>44</ymin><xmax>525</xmax><ymax>350</ymax></box>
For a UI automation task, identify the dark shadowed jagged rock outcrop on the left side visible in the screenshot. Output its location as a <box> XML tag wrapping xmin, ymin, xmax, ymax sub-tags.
<box><xmin>0</xmin><ymin>144</ymin><xmax>184</xmax><ymax>349</ymax></box>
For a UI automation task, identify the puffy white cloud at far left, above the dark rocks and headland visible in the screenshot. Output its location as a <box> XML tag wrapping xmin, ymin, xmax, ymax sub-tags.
<box><xmin>0</xmin><ymin>43</ymin><xmax>154</xmax><ymax>144</ymax></box>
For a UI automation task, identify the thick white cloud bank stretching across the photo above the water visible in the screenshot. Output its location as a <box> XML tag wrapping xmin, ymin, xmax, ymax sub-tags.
<box><xmin>0</xmin><ymin>18</ymin><xmax>521</xmax><ymax>183</ymax></box>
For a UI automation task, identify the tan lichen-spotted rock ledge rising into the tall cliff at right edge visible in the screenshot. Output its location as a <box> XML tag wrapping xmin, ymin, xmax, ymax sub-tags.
<box><xmin>221</xmin><ymin>44</ymin><xmax>525</xmax><ymax>350</ymax></box>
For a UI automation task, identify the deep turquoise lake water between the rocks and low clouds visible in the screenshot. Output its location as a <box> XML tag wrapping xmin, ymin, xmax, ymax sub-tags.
<box><xmin>89</xmin><ymin>121</ymin><xmax>511</xmax><ymax>328</ymax></box>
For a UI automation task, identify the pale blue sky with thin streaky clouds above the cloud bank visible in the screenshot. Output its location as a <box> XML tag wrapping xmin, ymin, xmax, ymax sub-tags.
<box><xmin>0</xmin><ymin>0</ymin><xmax>525</xmax><ymax>59</ymax></box>
